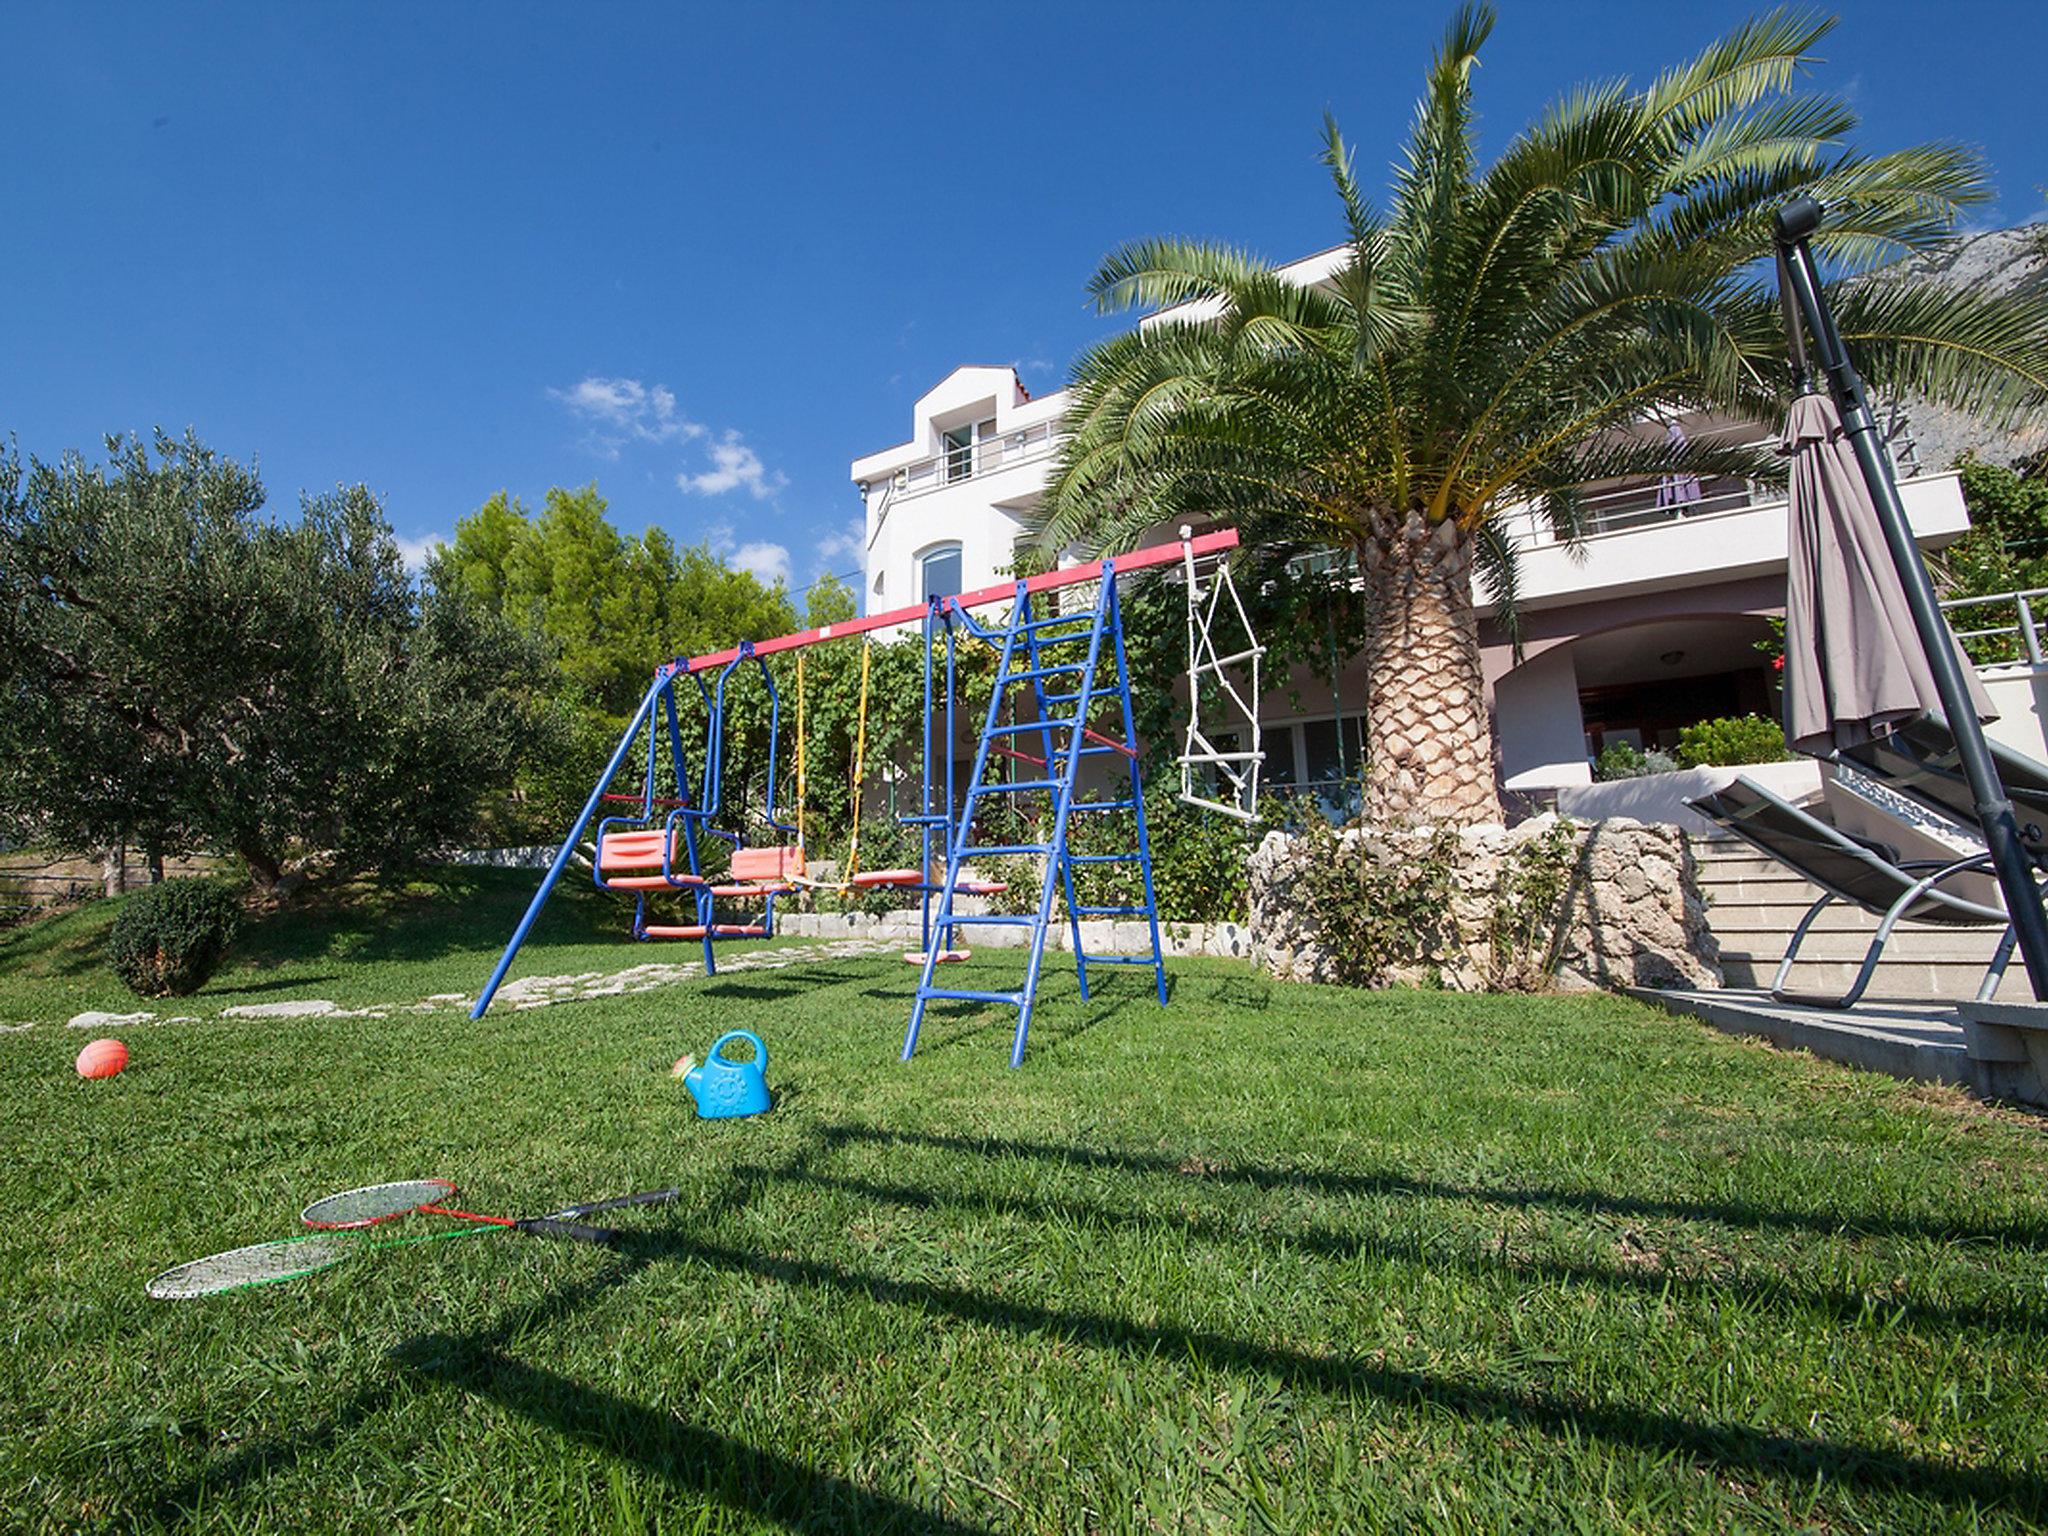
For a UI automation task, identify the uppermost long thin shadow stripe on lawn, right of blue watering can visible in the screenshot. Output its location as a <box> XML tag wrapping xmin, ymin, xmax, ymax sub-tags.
<box><xmin>819</xmin><ymin>1122</ymin><xmax>2048</xmax><ymax>1249</ymax></box>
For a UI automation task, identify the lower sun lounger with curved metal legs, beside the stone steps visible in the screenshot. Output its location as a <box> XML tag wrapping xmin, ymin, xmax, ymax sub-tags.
<box><xmin>1686</xmin><ymin>778</ymin><xmax>2013</xmax><ymax>1008</ymax></box>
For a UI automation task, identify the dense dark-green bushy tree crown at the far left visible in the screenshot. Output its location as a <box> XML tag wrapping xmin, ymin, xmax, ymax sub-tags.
<box><xmin>0</xmin><ymin>434</ymin><xmax>537</xmax><ymax>885</ymax></box>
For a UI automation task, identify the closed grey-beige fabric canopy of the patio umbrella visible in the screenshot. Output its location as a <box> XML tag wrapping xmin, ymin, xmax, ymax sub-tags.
<box><xmin>1778</xmin><ymin>393</ymin><xmax>1999</xmax><ymax>758</ymax></box>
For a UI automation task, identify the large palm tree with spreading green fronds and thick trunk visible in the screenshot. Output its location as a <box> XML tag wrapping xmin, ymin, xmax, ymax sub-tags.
<box><xmin>1038</xmin><ymin>4</ymin><xmax>2048</xmax><ymax>823</ymax></box>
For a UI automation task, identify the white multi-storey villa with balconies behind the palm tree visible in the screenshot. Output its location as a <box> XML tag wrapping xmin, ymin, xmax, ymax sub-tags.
<box><xmin>852</xmin><ymin>250</ymin><xmax>1968</xmax><ymax>805</ymax></box>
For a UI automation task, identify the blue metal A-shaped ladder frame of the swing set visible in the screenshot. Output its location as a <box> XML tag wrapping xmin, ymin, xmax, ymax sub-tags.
<box><xmin>903</xmin><ymin>561</ymin><xmax>1165</xmax><ymax>1067</ymax></box>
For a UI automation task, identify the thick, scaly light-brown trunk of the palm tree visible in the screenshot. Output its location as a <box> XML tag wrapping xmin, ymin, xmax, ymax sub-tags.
<box><xmin>1358</xmin><ymin>510</ymin><xmax>1501</xmax><ymax>825</ymax></box>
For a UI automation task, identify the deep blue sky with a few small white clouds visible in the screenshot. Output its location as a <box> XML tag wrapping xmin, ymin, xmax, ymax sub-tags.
<box><xmin>0</xmin><ymin>0</ymin><xmax>2048</xmax><ymax>606</ymax></box>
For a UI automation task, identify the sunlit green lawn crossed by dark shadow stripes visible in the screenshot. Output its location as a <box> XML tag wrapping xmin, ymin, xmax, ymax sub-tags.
<box><xmin>0</xmin><ymin>883</ymin><xmax>2048</xmax><ymax>1536</ymax></box>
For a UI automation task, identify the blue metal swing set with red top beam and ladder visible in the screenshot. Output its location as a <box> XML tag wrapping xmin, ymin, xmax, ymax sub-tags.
<box><xmin>471</xmin><ymin>528</ymin><xmax>1264</xmax><ymax>1065</ymax></box>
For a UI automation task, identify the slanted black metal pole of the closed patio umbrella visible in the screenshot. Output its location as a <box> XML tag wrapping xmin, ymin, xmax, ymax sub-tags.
<box><xmin>1774</xmin><ymin>197</ymin><xmax>2048</xmax><ymax>1001</ymax></box>
